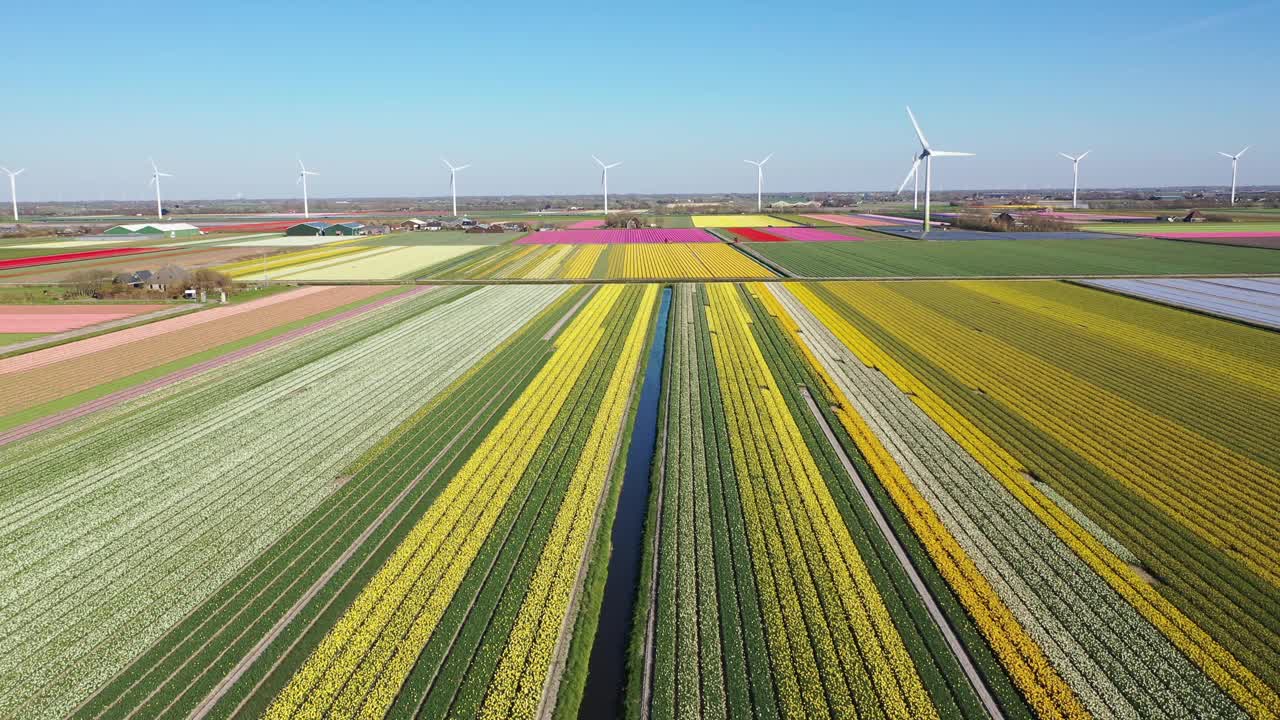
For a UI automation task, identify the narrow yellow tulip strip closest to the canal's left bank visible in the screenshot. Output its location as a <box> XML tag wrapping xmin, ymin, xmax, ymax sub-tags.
<box><xmin>480</xmin><ymin>286</ymin><xmax>658</xmax><ymax>719</ymax></box>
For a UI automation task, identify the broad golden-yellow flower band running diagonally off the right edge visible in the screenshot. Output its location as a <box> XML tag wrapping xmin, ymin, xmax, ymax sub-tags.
<box><xmin>829</xmin><ymin>283</ymin><xmax>1280</xmax><ymax>584</ymax></box>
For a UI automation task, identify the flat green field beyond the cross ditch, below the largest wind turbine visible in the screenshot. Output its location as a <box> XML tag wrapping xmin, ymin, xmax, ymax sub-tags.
<box><xmin>750</xmin><ymin>238</ymin><xmax>1280</xmax><ymax>278</ymax></box>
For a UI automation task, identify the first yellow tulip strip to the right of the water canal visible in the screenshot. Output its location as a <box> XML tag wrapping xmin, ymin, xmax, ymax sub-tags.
<box><xmin>707</xmin><ymin>284</ymin><xmax>937</xmax><ymax>717</ymax></box>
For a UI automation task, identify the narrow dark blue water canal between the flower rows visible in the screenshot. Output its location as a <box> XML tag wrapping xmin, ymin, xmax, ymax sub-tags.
<box><xmin>579</xmin><ymin>287</ymin><xmax>671</xmax><ymax>720</ymax></box>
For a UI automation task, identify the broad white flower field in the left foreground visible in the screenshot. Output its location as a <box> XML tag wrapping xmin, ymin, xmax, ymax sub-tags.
<box><xmin>0</xmin><ymin>287</ymin><xmax>563</xmax><ymax>717</ymax></box>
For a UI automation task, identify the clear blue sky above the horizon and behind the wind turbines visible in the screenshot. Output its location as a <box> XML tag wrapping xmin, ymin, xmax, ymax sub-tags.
<box><xmin>0</xmin><ymin>0</ymin><xmax>1280</xmax><ymax>200</ymax></box>
